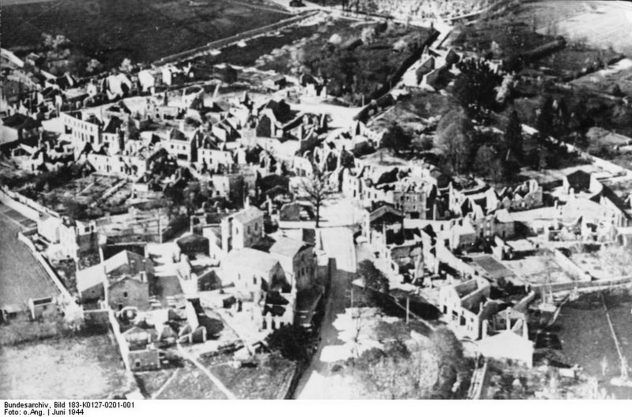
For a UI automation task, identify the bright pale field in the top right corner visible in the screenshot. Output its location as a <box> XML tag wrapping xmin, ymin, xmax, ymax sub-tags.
<box><xmin>518</xmin><ymin>1</ymin><xmax>632</xmax><ymax>54</ymax></box>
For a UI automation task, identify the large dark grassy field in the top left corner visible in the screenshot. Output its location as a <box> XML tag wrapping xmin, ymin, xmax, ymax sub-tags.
<box><xmin>1</xmin><ymin>0</ymin><xmax>287</xmax><ymax>68</ymax></box>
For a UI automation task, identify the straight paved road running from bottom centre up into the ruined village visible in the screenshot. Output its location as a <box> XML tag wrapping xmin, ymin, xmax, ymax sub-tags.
<box><xmin>295</xmin><ymin>227</ymin><xmax>356</xmax><ymax>399</ymax></box>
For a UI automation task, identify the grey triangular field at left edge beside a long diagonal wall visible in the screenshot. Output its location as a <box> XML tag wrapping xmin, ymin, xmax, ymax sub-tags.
<box><xmin>0</xmin><ymin>214</ymin><xmax>58</xmax><ymax>307</ymax></box>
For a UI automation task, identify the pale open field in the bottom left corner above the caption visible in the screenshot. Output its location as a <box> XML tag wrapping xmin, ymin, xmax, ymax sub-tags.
<box><xmin>0</xmin><ymin>335</ymin><xmax>126</xmax><ymax>399</ymax></box>
